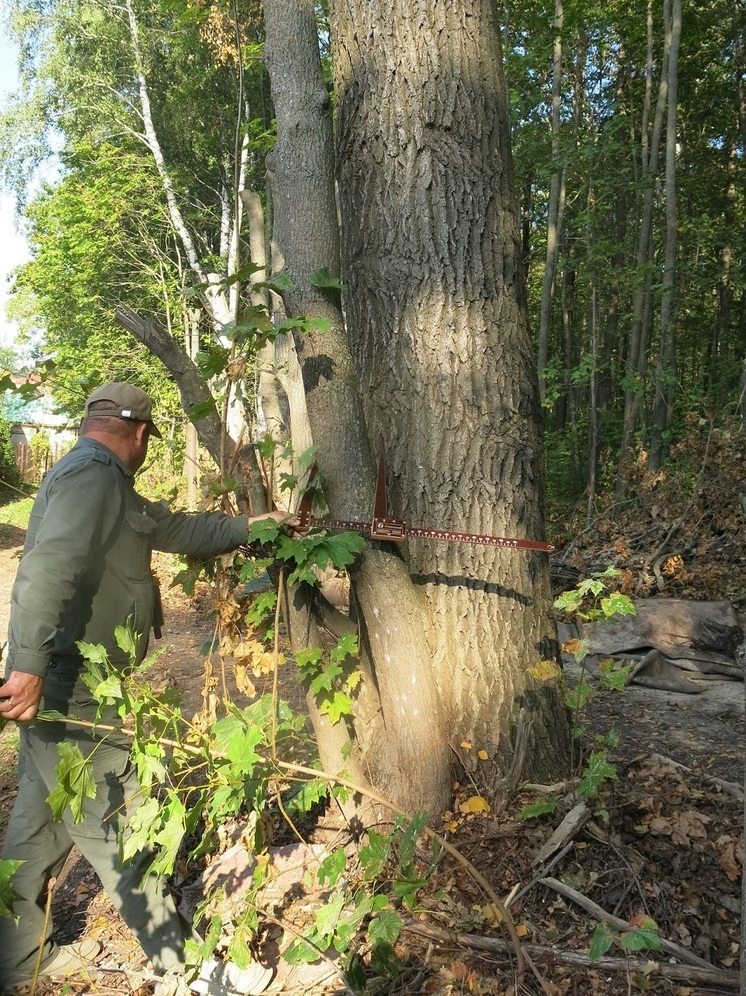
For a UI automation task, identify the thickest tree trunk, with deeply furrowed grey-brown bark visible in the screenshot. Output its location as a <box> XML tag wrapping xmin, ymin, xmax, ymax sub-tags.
<box><xmin>331</xmin><ymin>0</ymin><xmax>568</xmax><ymax>786</ymax></box>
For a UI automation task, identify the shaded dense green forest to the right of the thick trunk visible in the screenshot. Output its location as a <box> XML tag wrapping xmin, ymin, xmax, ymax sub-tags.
<box><xmin>505</xmin><ymin>0</ymin><xmax>746</xmax><ymax>510</ymax></box>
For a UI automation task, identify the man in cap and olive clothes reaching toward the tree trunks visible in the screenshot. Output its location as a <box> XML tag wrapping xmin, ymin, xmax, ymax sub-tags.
<box><xmin>0</xmin><ymin>383</ymin><xmax>297</xmax><ymax>992</ymax></box>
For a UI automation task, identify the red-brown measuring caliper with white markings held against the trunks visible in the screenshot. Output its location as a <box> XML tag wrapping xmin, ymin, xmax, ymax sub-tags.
<box><xmin>296</xmin><ymin>457</ymin><xmax>554</xmax><ymax>553</ymax></box>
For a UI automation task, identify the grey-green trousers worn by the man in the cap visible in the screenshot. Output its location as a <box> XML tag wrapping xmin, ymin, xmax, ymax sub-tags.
<box><xmin>0</xmin><ymin>661</ymin><xmax>190</xmax><ymax>992</ymax></box>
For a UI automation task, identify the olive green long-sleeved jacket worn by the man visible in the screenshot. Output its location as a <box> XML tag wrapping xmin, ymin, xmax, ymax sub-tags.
<box><xmin>7</xmin><ymin>436</ymin><xmax>248</xmax><ymax>676</ymax></box>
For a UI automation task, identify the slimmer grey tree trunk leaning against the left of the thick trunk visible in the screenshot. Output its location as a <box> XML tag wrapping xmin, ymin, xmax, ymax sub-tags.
<box><xmin>264</xmin><ymin>0</ymin><xmax>451</xmax><ymax>813</ymax></box>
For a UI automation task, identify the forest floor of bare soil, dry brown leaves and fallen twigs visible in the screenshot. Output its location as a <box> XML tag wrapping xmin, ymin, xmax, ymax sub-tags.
<box><xmin>0</xmin><ymin>436</ymin><xmax>746</xmax><ymax>996</ymax></box>
